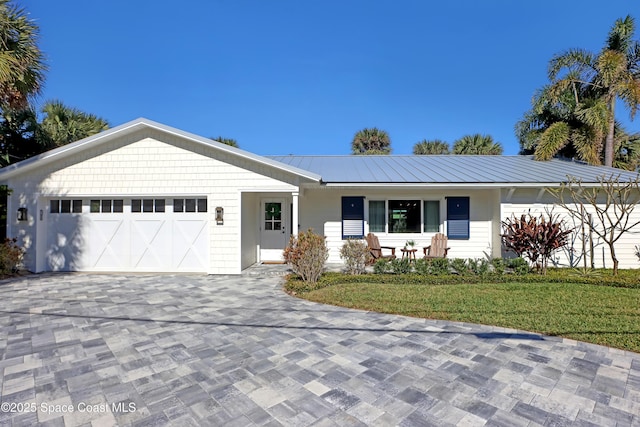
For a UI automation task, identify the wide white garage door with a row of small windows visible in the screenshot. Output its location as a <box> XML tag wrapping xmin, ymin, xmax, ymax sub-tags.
<box><xmin>45</xmin><ymin>197</ymin><xmax>209</xmax><ymax>272</ymax></box>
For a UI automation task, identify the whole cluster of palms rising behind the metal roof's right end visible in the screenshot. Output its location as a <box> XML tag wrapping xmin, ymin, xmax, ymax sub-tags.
<box><xmin>515</xmin><ymin>16</ymin><xmax>640</xmax><ymax>170</ymax></box>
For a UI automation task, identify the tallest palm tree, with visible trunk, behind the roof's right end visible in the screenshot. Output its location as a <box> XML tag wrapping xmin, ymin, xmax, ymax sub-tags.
<box><xmin>549</xmin><ymin>16</ymin><xmax>640</xmax><ymax>166</ymax></box>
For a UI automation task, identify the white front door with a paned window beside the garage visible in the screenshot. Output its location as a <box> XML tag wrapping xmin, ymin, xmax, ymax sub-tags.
<box><xmin>260</xmin><ymin>199</ymin><xmax>289</xmax><ymax>262</ymax></box>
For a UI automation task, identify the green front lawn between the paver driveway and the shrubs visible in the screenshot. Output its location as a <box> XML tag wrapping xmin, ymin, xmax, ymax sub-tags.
<box><xmin>290</xmin><ymin>271</ymin><xmax>640</xmax><ymax>353</ymax></box>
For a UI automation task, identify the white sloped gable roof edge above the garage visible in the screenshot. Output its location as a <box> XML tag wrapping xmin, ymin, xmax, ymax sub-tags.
<box><xmin>0</xmin><ymin>118</ymin><xmax>320</xmax><ymax>181</ymax></box>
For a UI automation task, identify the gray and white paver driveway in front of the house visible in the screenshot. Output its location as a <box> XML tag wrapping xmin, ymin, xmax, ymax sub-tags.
<box><xmin>0</xmin><ymin>274</ymin><xmax>640</xmax><ymax>426</ymax></box>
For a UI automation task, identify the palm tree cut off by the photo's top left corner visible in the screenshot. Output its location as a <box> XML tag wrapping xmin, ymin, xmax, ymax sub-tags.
<box><xmin>0</xmin><ymin>0</ymin><xmax>47</xmax><ymax>110</ymax></box>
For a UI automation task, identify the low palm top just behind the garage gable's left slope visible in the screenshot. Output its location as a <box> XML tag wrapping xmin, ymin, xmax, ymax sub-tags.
<box><xmin>38</xmin><ymin>101</ymin><xmax>109</xmax><ymax>148</ymax></box>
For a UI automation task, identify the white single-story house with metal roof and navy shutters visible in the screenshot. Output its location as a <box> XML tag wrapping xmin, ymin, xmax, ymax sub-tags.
<box><xmin>0</xmin><ymin>119</ymin><xmax>640</xmax><ymax>274</ymax></box>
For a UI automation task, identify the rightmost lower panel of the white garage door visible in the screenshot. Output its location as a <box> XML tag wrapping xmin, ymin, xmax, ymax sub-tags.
<box><xmin>172</xmin><ymin>219</ymin><xmax>208</xmax><ymax>271</ymax></box>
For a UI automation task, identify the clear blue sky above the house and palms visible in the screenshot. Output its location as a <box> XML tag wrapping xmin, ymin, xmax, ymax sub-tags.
<box><xmin>18</xmin><ymin>0</ymin><xmax>640</xmax><ymax>154</ymax></box>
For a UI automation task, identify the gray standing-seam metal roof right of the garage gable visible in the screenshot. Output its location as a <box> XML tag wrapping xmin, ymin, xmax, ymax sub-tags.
<box><xmin>266</xmin><ymin>155</ymin><xmax>638</xmax><ymax>185</ymax></box>
